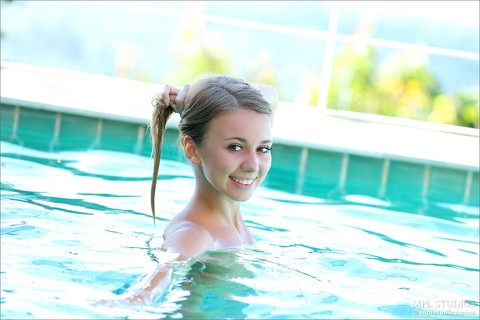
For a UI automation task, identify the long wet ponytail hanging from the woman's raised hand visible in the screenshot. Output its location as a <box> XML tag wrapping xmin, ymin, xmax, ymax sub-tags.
<box><xmin>150</xmin><ymin>93</ymin><xmax>173</xmax><ymax>224</ymax></box>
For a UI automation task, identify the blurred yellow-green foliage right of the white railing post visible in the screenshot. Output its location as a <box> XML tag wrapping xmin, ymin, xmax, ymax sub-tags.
<box><xmin>328</xmin><ymin>40</ymin><xmax>479</xmax><ymax>128</ymax></box>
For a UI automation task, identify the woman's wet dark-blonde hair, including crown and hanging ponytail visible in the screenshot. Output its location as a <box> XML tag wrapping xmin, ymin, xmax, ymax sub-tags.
<box><xmin>150</xmin><ymin>75</ymin><xmax>272</xmax><ymax>222</ymax></box>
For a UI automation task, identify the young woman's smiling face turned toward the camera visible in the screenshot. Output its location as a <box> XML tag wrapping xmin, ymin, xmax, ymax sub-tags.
<box><xmin>192</xmin><ymin>108</ymin><xmax>272</xmax><ymax>201</ymax></box>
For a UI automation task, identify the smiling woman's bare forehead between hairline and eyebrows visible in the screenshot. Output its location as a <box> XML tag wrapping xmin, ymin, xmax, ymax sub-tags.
<box><xmin>207</xmin><ymin>108</ymin><xmax>271</xmax><ymax>140</ymax></box>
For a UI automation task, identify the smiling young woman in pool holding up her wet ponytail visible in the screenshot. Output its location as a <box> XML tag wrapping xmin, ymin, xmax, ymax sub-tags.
<box><xmin>97</xmin><ymin>76</ymin><xmax>277</xmax><ymax>304</ymax></box>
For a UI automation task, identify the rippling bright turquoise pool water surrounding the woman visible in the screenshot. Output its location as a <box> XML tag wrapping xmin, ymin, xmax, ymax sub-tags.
<box><xmin>0</xmin><ymin>141</ymin><xmax>480</xmax><ymax>319</ymax></box>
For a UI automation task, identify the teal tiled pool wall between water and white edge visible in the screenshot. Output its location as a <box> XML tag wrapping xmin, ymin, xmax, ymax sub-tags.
<box><xmin>0</xmin><ymin>104</ymin><xmax>480</xmax><ymax>214</ymax></box>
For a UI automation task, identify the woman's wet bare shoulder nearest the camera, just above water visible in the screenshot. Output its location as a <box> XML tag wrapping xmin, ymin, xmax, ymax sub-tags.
<box><xmin>163</xmin><ymin>220</ymin><xmax>215</xmax><ymax>258</ymax></box>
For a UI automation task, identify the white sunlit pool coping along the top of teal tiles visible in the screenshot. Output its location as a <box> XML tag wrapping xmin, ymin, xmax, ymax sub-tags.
<box><xmin>0</xmin><ymin>62</ymin><xmax>480</xmax><ymax>172</ymax></box>
